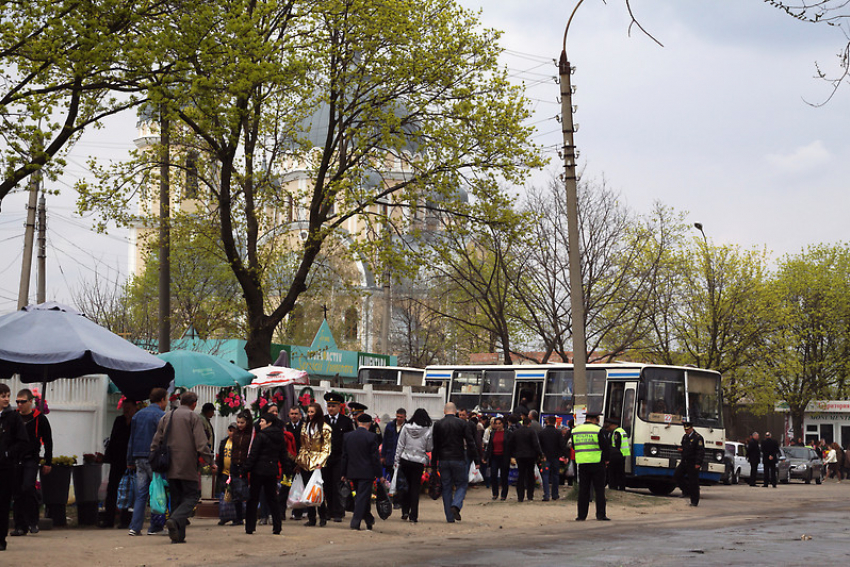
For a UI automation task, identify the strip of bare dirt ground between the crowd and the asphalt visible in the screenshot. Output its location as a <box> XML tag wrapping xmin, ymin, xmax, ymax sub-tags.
<box><xmin>0</xmin><ymin>481</ymin><xmax>850</xmax><ymax>567</ymax></box>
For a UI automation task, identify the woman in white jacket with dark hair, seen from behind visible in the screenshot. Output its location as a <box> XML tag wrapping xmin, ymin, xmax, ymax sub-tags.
<box><xmin>394</xmin><ymin>408</ymin><xmax>434</xmax><ymax>523</ymax></box>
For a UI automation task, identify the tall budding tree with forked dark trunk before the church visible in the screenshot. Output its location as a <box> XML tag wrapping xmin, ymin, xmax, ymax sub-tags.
<box><xmin>83</xmin><ymin>0</ymin><xmax>540</xmax><ymax>366</ymax></box>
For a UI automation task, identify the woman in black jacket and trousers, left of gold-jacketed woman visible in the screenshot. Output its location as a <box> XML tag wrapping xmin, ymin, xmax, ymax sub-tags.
<box><xmin>245</xmin><ymin>413</ymin><xmax>293</xmax><ymax>535</ymax></box>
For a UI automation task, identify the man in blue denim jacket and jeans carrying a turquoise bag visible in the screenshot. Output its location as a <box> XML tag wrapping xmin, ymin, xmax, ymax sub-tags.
<box><xmin>127</xmin><ymin>388</ymin><xmax>168</xmax><ymax>536</ymax></box>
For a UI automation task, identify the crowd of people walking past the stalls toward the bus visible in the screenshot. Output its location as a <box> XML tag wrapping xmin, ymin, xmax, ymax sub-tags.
<box><xmin>0</xmin><ymin>384</ymin><xmax>644</xmax><ymax>549</ymax></box>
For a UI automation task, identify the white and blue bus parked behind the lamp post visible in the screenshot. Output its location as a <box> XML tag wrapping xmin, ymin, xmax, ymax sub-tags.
<box><xmin>425</xmin><ymin>363</ymin><xmax>725</xmax><ymax>494</ymax></box>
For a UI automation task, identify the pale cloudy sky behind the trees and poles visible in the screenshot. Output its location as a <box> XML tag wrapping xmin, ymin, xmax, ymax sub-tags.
<box><xmin>0</xmin><ymin>0</ymin><xmax>850</xmax><ymax>313</ymax></box>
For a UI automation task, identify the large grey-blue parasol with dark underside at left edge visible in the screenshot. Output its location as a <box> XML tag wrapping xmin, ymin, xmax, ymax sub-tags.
<box><xmin>0</xmin><ymin>302</ymin><xmax>174</xmax><ymax>400</ymax></box>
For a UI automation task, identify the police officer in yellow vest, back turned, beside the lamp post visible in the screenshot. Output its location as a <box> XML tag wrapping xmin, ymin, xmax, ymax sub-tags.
<box><xmin>572</xmin><ymin>412</ymin><xmax>610</xmax><ymax>522</ymax></box>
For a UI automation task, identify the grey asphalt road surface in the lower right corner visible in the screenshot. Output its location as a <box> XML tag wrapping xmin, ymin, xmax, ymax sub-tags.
<box><xmin>419</xmin><ymin>481</ymin><xmax>850</xmax><ymax>567</ymax></box>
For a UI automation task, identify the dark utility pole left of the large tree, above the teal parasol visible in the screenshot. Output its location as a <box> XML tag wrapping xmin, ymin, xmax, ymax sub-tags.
<box><xmin>159</xmin><ymin>110</ymin><xmax>171</xmax><ymax>352</ymax></box>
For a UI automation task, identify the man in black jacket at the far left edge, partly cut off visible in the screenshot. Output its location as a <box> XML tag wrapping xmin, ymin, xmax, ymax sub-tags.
<box><xmin>0</xmin><ymin>383</ymin><xmax>29</xmax><ymax>551</ymax></box>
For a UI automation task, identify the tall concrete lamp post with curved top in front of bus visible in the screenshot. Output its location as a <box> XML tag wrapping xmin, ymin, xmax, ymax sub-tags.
<box><xmin>558</xmin><ymin>0</ymin><xmax>587</xmax><ymax>413</ymax></box>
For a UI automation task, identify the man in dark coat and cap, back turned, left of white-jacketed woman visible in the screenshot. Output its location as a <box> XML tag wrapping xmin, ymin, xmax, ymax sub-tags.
<box><xmin>342</xmin><ymin>413</ymin><xmax>381</xmax><ymax>530</ymax></box>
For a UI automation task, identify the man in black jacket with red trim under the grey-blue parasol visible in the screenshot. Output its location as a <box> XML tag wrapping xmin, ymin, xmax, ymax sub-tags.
<box><xmin>12</xmin><ymin>388</ymin><xmax>53</xmax><ymax>536</ymax></box>
